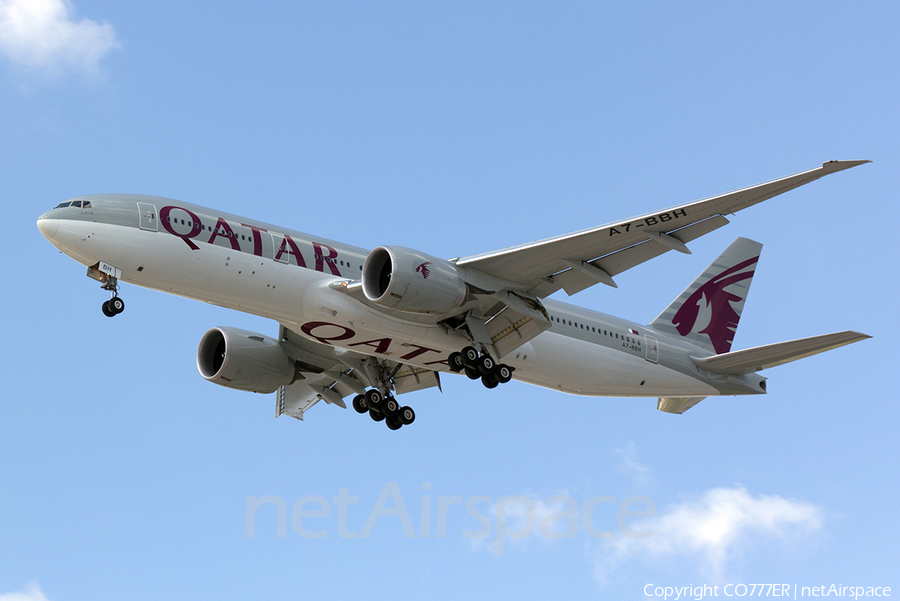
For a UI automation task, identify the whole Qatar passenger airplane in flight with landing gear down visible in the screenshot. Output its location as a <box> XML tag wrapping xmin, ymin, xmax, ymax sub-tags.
<box><xmin>37</xmin><ymin>161</ymin><xmax>870</xmax><ymax>430</ymax></box>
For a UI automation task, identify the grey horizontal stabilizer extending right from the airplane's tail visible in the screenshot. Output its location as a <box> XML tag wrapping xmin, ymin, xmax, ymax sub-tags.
<box><xmin>691</xmin><ymin>330</ymin><xmax>871</xmax><ymax>375</ymax></box>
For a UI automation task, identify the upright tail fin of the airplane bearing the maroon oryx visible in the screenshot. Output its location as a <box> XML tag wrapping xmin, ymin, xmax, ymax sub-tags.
<box><xmin>650</xmin><ymin>238</ymin><xmax>762</xmax><ymax>353</ymax></box>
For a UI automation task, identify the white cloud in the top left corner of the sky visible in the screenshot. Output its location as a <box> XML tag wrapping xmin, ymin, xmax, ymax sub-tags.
<box><xmin>0</xmin><ymin>0</ymin><xmax>119</xmax><ymax>72</ymax></box>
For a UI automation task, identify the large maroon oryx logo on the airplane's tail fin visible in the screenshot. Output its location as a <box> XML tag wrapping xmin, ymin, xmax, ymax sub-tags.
<box><xmin>672</xmin><ymin>257</ymin><xmax>759</xmax><ymax>353</ymax></box>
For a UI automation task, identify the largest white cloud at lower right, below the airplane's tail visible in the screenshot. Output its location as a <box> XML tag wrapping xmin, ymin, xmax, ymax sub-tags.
<box><xmin>594</xmin><ymin>487</ymin><xmax>823</xmax><ymax>584</ymax></box>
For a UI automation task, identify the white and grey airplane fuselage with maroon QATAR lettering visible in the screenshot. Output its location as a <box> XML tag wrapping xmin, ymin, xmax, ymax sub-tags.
<box><xmin>38</xmin><ymin>197</ymin><xmax>751</xmax><ymax>397</ymax></box>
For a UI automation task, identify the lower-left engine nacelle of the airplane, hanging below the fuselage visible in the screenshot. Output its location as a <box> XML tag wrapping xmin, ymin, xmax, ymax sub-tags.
<box><xmin>197</xmin><ymin>328</ymin><xmax>297</xmax><ymax>393</ymax></box>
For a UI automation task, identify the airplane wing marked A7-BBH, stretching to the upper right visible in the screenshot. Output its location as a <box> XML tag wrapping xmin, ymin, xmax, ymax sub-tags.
<box><xmin>456</xmin><ymin>161</ymin><xmax>870</xmax><ymax>298</ymax></box>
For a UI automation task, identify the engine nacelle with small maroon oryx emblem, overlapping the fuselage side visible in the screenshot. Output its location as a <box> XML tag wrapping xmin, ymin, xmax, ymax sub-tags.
<box><xmin>362</xmin><ymin>246</ymin><xmax>466</xmax><ymax>315</ymax></box>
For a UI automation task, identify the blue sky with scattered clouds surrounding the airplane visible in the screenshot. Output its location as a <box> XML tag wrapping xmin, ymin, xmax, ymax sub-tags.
<box><xmin>0</xmin><ymin>0</ymin><xmax>900</xmax><ymax>601</ymax></box>
